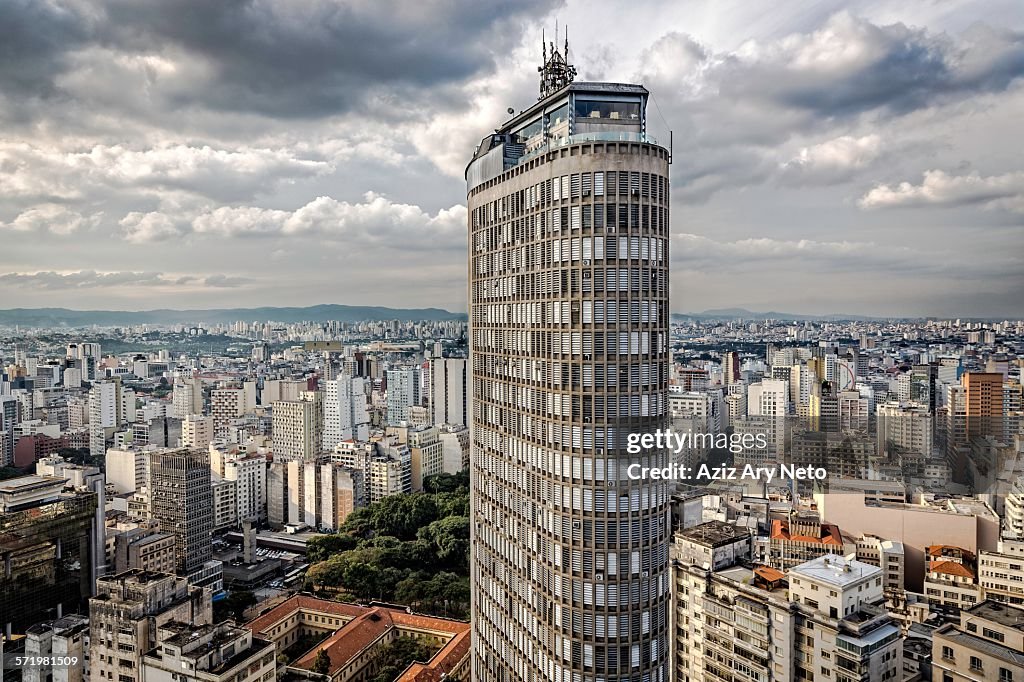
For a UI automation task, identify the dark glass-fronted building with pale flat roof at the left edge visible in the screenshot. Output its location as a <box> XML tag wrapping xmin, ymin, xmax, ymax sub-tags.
<box><xmin>0</xmin><ymin>476</ymin><xmax>102</xmax><ymax>636</ymax></box>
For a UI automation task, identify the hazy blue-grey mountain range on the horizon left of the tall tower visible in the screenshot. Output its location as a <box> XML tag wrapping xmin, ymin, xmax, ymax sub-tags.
<box><xmin>0</xmin><ymin>304</ymin><xmax>466</xmax><ymax>328</ymax></box>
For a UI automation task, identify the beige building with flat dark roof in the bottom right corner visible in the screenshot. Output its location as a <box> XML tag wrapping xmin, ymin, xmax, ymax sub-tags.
<box><xmin>932</xmin><ymin>601</ymin><xmax>1024</xmax><ymax>682</ymax></box>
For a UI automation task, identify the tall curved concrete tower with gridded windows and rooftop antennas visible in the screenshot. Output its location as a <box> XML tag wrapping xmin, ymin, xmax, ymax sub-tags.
<box><xmin>466</xmin><ymin>48</ymin><xmax>671</xmax><ymax>682</ymax></box>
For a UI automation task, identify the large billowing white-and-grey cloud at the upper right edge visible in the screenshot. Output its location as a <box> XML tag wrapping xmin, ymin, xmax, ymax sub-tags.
<box><xmin>719</xmin><ymin>13</ymin><xmax>1024</xmax><ymax>120</ymax></box>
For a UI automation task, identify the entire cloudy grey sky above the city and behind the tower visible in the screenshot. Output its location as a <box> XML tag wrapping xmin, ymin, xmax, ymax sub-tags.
<box><xmin>0</xmin><ymin>0</ymin><xmax>1024</xmax><ymax>317</ymax></box>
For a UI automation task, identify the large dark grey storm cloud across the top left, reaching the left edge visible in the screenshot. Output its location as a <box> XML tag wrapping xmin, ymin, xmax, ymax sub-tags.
<box><xmin>0</xmin><ymin>0</ymin><xmax>560</xmax><ymax>118</ymax></box>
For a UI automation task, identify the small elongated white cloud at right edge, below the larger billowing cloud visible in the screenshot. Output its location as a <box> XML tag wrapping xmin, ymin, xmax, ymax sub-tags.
<box><xmin>858</xmin><ymin>170</ymin><xmax>1024</xmax><ymax>213</ymax></box>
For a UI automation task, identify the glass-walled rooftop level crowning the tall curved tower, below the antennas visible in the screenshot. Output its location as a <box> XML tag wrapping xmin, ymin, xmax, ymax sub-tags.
<box><xmin>466</xmin><ymin>83</ymin><xmax>654</xmax><ymax>189</ymax></box>
